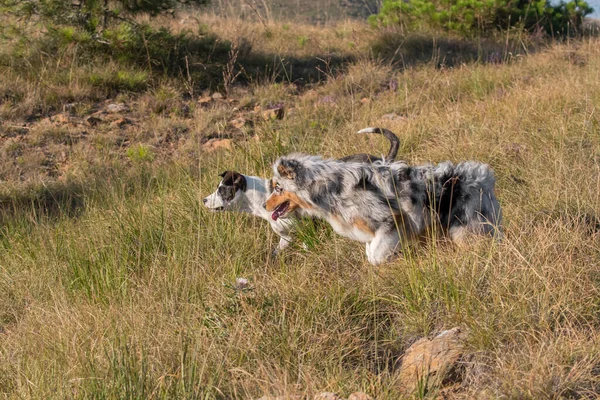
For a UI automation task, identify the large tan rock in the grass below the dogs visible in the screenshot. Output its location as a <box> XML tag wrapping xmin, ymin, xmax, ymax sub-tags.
<box><xmin>398</xmin><ymin>328</ymin><xmax>466</xmax><ymax>394</ymax></box>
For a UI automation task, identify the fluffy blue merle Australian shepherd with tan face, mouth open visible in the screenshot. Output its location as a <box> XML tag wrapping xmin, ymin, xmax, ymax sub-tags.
<box><xmin>265</xmin><ymin>154</ymin><xmax>501</xmax><ymax>264</ymax></box>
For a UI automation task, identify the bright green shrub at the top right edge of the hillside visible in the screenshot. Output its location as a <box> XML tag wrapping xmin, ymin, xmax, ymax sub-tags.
<box><xmin>371</xmin><ymin>0</ymin><xmax>593</xmax><ymax>36</ymax></box>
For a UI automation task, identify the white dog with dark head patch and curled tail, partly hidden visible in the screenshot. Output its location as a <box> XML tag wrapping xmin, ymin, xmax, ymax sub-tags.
<box><xmin>202</xmin><ymin>128</ymin><xmax>400</xmax><ymax>255</ymax></box>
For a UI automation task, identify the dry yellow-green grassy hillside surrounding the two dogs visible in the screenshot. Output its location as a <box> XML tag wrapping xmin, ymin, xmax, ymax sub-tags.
<box><xmin>0</xmin><ymin>10</ymin><xmax>600</xmax><ymax>399</ymax></box>
